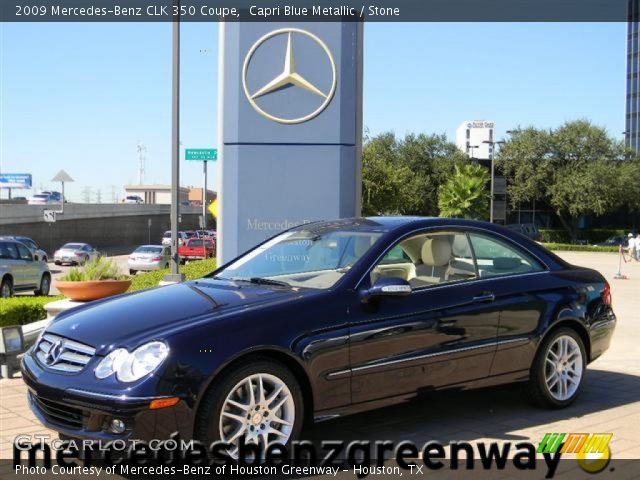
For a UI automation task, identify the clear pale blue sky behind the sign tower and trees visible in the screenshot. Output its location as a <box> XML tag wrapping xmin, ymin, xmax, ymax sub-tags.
<box><xmin>0</xmin><ymin>23</ymin><xmax>626</xmax><ymax>202</ymax></box>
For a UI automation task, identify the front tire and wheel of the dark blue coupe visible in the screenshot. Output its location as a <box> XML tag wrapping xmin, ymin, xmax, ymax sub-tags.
<box><xmin>194</xmin><ymin>357</ymin><xmax>305</xmax><ymax>458</ymax></box>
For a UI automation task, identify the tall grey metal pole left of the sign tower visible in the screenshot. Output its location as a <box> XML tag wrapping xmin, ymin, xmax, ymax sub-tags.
<box><xmin>165</xmin><ymin>0</ymin><xmax>184</xmax><ymax>282</ymax></box>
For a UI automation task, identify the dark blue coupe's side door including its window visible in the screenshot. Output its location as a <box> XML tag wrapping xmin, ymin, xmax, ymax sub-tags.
<box><xmin>350</xmin><ymin>230</ymin><xmax>500</xmax><ymax>403</ymax></box>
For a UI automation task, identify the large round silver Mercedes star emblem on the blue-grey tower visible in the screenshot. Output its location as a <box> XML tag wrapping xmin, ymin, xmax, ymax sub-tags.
<box><xmin>242</xmin><ymin>28</ymin><xmax>337</xmax><ymax>124</ymax></box>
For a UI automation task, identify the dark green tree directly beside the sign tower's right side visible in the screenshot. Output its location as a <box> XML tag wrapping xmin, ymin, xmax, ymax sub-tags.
<box><xmin>362</xmin><ymin>132</ymin><xmax>469</xmax><ymax>215</ymax></box>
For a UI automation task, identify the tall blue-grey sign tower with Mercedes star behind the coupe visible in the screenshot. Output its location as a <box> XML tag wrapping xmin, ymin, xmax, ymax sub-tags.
<box><xmin>218</xmin><ymin>22</ymin><xmax>363</xmax><ymax>262</ymax></box>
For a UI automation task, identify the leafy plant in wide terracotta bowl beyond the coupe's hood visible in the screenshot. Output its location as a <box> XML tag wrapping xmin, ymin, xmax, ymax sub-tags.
<box><xmin>56</xmin><ymin>257</ymin><xmax>131</xmax><ymax>302</ymax></box>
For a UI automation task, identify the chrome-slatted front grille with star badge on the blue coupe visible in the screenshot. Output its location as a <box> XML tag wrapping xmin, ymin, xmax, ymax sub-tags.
<box><xmin>36</xmin><ymin>333</ymin><xmax>96</xmax><ymax>373</ymax></box>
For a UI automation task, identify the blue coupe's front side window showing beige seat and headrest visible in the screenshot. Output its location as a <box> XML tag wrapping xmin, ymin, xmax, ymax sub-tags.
<box><xmin>371</xmin><ymin>231</ymin><xmax>476</xmax><ymax>288</ymax></box>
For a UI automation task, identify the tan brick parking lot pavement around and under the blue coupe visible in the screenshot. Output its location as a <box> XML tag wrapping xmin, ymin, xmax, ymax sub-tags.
<box><xmin>0</xmin><ymin>252</ymin><xmax>640</xmax><ymax>459</ymax></box>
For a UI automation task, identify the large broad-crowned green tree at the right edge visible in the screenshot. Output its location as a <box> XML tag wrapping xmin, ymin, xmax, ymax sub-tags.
<box><xmin>496</xmin><ymin>120</ymin><xmax>640</xmax><ymax>239</ymax></box>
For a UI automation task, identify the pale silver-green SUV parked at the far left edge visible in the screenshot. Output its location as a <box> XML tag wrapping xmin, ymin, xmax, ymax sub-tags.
<box><xmin>0</xmin><ymin>238</ymin><xmax>51</xmax><ymax>298</ymax></box>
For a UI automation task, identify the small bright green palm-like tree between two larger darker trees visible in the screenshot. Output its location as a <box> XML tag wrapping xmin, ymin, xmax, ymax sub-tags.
<box><xmin>438</xmin><ymin>165</ymin><xmax>490</xmax><ymax>220</ymax></box>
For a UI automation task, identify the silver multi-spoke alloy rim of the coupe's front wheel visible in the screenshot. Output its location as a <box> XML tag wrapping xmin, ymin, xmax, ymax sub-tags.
<box><xmin>219</xmin><ymin>373</ymin><xmax>296</xmax><ymax>459</ymax></box>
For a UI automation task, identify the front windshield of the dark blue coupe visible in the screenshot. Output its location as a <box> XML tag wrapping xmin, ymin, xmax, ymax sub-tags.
<box><xmin>215</xmin><ymin>229</ymin><xmax>382</xmax><ymax>289</ymax></box>
